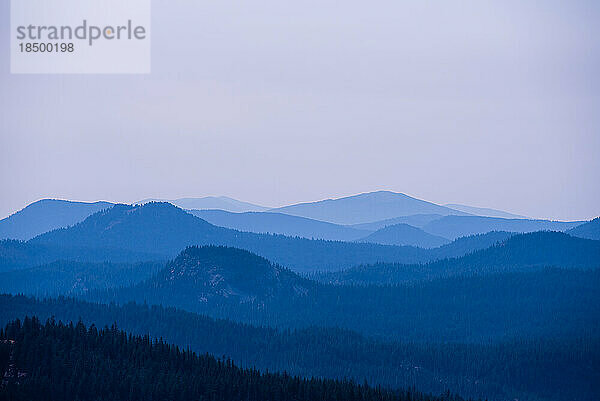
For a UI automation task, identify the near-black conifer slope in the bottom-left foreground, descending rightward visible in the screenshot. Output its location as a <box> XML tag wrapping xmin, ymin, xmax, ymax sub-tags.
<box><xmin>0</xmin><ymin>318</ymin><xmax>458</xmax><ymax>401</ymax></box>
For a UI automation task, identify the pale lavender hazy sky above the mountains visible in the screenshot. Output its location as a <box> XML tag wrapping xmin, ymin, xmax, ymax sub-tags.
<box><xmin>0</xmin><ymin>0</ymin><xmax>600</xmax><ymax>220</ymax></box>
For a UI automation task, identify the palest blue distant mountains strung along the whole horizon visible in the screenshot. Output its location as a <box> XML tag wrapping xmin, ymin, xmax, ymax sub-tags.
<box><xmin>0</xmin><ymin>191</ymin><xmax>599</xmax><ymax>248</ymax></box>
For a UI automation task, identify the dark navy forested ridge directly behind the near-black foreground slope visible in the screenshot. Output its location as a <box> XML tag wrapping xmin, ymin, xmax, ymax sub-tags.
<box><xmin>0</xmin><ymin>295</ymin><xmax>600</xmax><ymax>401</ymax></box>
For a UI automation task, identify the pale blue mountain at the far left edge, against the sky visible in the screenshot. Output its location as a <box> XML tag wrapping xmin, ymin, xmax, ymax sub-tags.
<box><xmin>0</xmin><ymin>199</ymin><xmax>113</xmax><ymax>240</ymax></box>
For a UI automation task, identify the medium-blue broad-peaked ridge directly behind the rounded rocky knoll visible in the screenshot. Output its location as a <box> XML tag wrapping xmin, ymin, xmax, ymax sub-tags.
<box><xmin>29</xmin><ymin>202</ymin><xmax>428</xmax><ymax>271</ymax></box>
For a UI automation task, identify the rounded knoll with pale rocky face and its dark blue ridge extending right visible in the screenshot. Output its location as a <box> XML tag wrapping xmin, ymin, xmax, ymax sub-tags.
<box><xmin>85</xmin><ymin>242</ymin><xmax>600</xmax><ymax>342</ymax></box>
